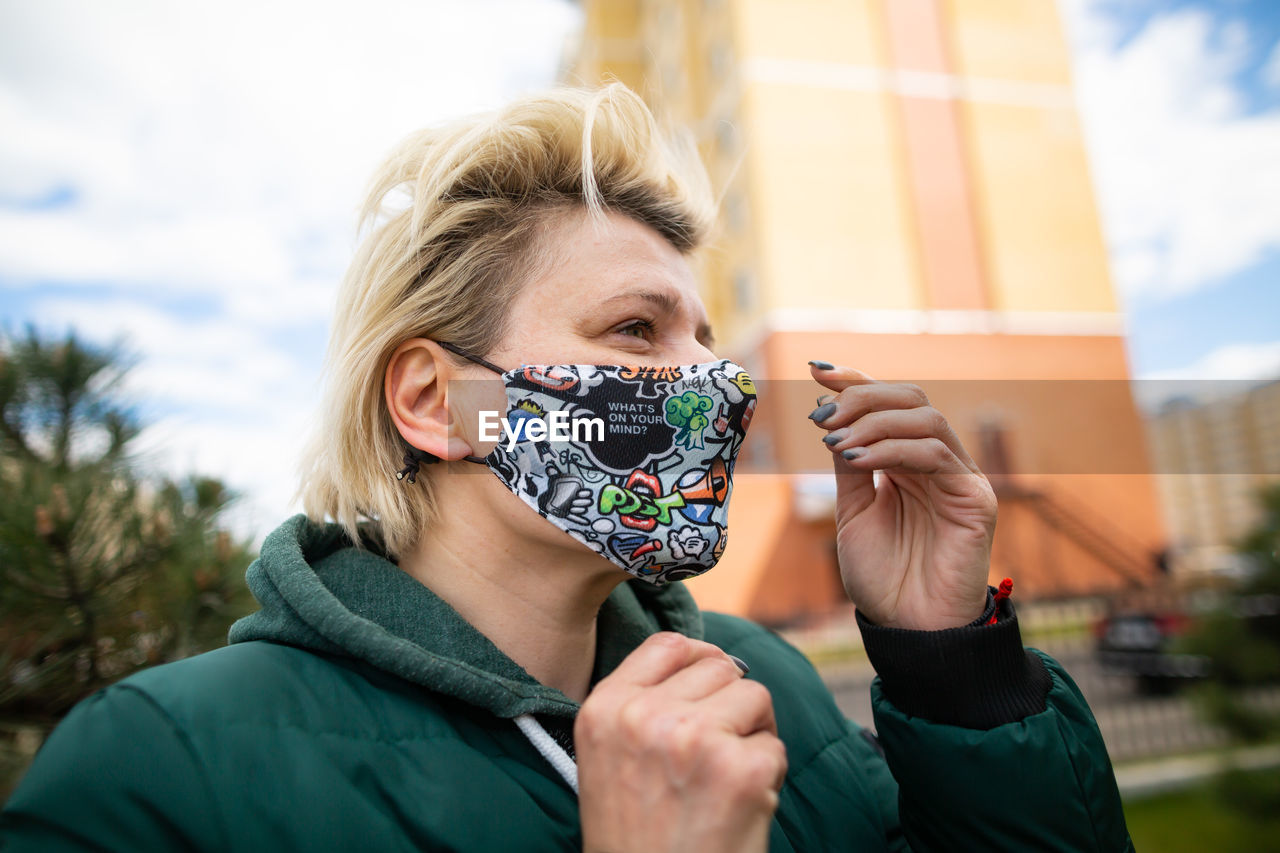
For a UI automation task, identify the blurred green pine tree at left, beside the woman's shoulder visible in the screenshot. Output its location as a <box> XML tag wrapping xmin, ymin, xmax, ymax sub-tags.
<box><xmin>0</xmin><ymin>329</ymin><xmax>252</xmax><ymax>726</ymax></box>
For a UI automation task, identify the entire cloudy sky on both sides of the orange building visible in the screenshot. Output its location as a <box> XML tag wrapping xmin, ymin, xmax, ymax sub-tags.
<box><xmin>0</xmin><ymin>0</ymin><xmax>1280</xmax><ymax>538</ymax></box>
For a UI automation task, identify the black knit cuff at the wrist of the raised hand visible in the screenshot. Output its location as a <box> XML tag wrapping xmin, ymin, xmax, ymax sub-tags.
<box><xmin>856</xmin><ymin>588</ymin><xmax>1052</xmax><ymax>730</ymax></box>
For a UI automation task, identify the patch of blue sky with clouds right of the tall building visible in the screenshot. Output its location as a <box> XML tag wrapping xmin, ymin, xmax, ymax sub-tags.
<box><xmin>1061</xmin><ymin>0</ymin><xmax>1280</xmax><ymax>379</ymax></box>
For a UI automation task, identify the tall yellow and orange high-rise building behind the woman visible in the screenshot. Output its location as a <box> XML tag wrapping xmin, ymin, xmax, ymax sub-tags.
<box><xmin>566</xmin><ymin>0</ymin><xmax>1164</xmax><ymax>622</ymax></box>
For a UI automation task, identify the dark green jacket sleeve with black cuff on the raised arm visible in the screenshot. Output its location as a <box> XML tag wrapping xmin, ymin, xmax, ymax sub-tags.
<box><xmin>859</xmin><ymin>591</ymin><xmax>1133</xmax><ymax>853</ymax></box>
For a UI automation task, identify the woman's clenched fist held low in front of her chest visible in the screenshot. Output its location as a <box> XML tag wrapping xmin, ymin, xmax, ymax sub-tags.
<box><xmin>573</xmin><ymin>633</ymin><xmax>787</xmax><ymax>853</ymax></box>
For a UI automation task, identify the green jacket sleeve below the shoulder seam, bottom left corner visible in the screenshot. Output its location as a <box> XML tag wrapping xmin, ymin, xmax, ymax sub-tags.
<box><xmin>0</xmin><ymin>684</ymin><xmax>225</xmax><ymax>853</ymax></box>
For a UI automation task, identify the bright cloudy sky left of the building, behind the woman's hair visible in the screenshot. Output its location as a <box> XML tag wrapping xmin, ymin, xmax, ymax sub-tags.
<box><xmin>0</xmin><ymin>0</ymin><xmax>581</xmax><ymax>537</ymax></box>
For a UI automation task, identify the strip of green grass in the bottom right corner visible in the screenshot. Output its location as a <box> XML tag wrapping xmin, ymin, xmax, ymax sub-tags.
<box><xmin>1124</xmin><ymin>767</ymin><xmax>1280</xmax><ymax>853</ymax></box>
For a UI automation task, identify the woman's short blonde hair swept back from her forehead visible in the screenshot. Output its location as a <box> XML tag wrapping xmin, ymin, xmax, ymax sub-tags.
<box><xmin>298</xmin><ymin>83</ymin><xmax>716</xmax><ymax>558</ymax></box>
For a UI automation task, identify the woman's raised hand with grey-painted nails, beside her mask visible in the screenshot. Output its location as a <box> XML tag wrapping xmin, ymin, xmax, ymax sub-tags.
<box><xmin>810</xmin><ymin>361</ymin><xmax>996</xmax><ymax>630</ymax></box>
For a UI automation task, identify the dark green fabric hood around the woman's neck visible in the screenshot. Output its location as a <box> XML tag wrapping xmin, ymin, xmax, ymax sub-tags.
<box><xmin>228</xmin><ymin>515</ymin><xmax>703</xmax><ymax>717</ymax></box>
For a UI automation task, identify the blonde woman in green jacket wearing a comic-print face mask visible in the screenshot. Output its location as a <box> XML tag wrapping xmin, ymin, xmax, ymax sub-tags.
<box><xmin>3</xmin><ymin>85</ymin><xmax>1129</xmax><ymax>852</ymax></box>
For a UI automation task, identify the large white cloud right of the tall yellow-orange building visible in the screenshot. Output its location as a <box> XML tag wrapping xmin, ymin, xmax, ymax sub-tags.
<box><xmin>1062</xmin><ymin>0</ymin><xmax>1280</xmax><ymax>301</ymax></box>
